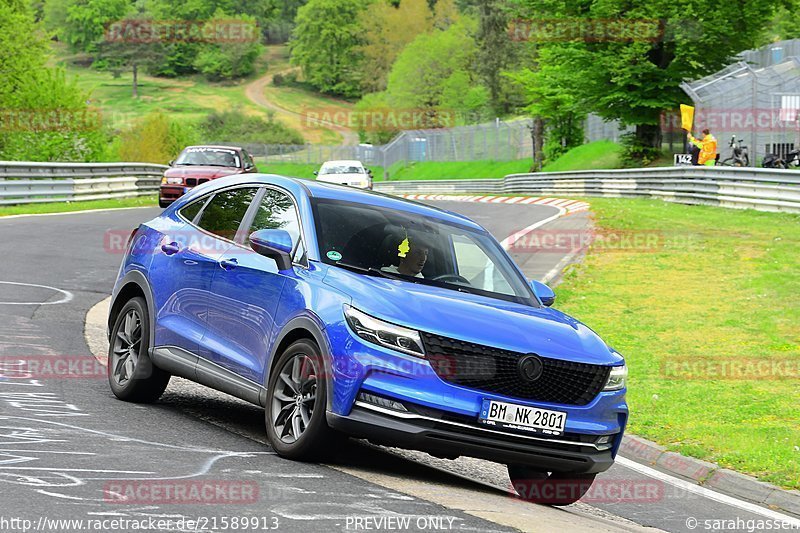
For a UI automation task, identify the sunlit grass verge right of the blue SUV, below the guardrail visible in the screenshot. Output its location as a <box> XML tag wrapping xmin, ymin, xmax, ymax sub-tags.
<box><xmin>557</xmin><ymin>198</ymin><xmax>800</xmax><ymax>489</ymax></box>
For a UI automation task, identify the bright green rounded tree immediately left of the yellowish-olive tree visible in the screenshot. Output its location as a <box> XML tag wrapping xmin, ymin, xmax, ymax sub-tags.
<box><xmin>289</xmin><ymin>0</ymin><xmax>370</xmax><ymax>97</ymax></box>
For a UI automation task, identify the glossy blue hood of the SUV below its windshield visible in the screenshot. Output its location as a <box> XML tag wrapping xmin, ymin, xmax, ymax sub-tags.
<box><xmin>325</xmin><ymin>266</ymin><xmax>623</xmax><ymax>365</ymax></box>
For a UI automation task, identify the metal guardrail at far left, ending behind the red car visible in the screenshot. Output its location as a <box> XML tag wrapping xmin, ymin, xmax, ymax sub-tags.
<box><xmin>0</xmin><ymin>161</ymin><xmax>169</xmax><ymax>205</ymax></box>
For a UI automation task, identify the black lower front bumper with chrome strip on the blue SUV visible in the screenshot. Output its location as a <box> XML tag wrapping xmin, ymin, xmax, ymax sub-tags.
<box><xmin>327</xmin><ymin>402</ymin><xmax>614</xmax><ymax>474</ymax></box>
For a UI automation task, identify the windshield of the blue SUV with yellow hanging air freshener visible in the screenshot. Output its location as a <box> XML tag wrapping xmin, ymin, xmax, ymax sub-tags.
<box><xmin>313</xmin><ymin>199</ymin><xmax>538</xmax><ymax>306</ymax></box>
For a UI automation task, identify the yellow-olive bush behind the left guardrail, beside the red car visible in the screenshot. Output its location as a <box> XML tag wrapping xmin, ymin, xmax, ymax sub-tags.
<box><xmin>118</xmin><ymin>113</ymin><xmax>199</xmax><ymax>164</ymax></box>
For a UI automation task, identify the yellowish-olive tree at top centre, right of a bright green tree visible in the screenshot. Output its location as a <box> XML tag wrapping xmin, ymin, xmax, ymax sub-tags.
<box><xmin>360</xmin><ymin>0</ymin><xmax>433</xmax><ymax>93</ymax></box>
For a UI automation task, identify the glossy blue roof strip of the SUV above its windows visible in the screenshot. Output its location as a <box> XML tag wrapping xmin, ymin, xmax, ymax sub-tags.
<box><xmin>176</xmin><ymin>173</ymin><xmax>483</xmax><ymax>230</ymax></box>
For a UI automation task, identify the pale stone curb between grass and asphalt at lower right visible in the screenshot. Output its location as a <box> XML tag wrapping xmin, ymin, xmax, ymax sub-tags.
<box><xmin>619</xmin><ymin>435</ymin><xmax>800</xmax><ymax>516</ymax></box>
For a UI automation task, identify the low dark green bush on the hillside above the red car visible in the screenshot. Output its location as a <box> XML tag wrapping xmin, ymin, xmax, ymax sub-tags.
<box><xmin>200</xmin><ymin>110</ymin><xmax>305</xmax><ymax>144</ymax></box>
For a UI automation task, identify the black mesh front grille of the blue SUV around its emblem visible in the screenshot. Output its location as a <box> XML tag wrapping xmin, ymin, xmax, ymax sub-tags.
<box><xmin>421</xmin><ymin>333</ymin><xmax>611</xmax><ymax>405</ymax></box>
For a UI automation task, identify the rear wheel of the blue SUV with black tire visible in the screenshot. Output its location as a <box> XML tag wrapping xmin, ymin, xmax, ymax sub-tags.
<box><xmin>108</xmin><ymin>296</ymin><xmax>170</xmax><ymax>403</ymax></box>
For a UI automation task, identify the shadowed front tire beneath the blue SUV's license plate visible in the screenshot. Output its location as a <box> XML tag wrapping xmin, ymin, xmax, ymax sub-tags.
<box><xmin>508</xmin><ymin>465</ymin><xmax>597</xmax><ymax>506</ymax></box>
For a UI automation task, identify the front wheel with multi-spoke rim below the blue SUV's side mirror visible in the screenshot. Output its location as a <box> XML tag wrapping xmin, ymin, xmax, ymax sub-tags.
<box><xmin>264</xmin><ymin>339</ymin><xmax>342</xmax><ymax>461</ymax></box>
